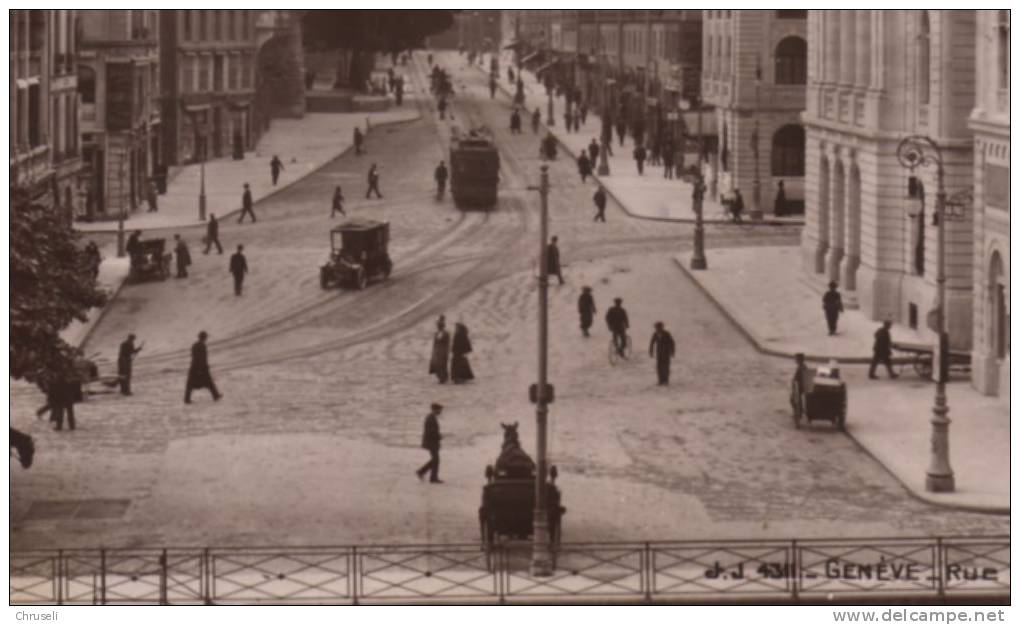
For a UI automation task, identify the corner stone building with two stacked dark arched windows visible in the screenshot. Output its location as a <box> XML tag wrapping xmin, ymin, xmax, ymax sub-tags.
<box><xmin>702</xmin><ymin>9</ymin><xmax>808</xmax><ymax>217</ymax></box>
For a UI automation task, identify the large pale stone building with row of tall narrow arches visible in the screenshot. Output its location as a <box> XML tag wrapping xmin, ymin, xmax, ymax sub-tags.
<box><xmin>801</xmin><ymin>10</ymin><xmax>975</xmax><ymax>349</ymax></box>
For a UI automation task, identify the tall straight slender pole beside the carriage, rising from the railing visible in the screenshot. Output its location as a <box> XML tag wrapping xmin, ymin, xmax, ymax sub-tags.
<box><xmin>531</xmin><ymin>165</ymin><xmax>553</xmax><ymax>576</ymax></box>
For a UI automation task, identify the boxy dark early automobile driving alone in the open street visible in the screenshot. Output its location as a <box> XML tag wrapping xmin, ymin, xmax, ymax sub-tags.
<box><xmin>319</xmin><ymin>219</ymin><xmax>393</xmax><ymax>289</ymax></box>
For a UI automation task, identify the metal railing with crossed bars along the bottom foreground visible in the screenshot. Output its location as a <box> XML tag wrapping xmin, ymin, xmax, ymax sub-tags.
<box><xmin>10</xmin><ymin>536</ymin><xmax>1010</xmax><ymax>605</ymax></box>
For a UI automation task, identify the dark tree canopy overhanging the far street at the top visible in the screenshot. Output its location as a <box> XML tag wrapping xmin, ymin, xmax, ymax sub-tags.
<box><xmin>302</xmin><ymin>9</ymin><xmax>453</xmax><ymax>52</ymax></box>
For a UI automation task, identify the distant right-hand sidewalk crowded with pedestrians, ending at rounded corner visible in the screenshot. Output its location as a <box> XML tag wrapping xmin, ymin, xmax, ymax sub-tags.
<box><xmin>479</xmin><ymin>53</ymin><xmax>804</xmax><ymax>225</ymax></box>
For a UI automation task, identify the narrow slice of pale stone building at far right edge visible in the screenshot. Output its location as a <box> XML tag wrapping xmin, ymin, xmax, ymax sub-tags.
<box><xmin>969</xmin><ymin>10</ymin><xmax>1010</xmax><ymax>395</ymax></box>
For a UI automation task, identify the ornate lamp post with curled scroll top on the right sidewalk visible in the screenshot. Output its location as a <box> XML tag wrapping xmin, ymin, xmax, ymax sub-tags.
<box><xmin>896</xmin><ymin>135</ymin><xmax>956</xmax><ymax>492</ymax></box>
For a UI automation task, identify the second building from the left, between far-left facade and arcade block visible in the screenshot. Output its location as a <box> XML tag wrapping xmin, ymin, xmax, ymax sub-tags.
<box><xmin>78</xmin><ymin>9</ymin><xmax>161</xmax><ymax>220</ymax></box>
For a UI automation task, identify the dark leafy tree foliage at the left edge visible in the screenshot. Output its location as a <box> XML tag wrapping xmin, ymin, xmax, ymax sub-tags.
<box><xmin>10</xmin><ymin>191</ymin><xmax>107</xmax><ymax>384</ymax></box>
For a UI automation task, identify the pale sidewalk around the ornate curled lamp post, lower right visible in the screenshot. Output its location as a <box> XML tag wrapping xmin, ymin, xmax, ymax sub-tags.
<box><xmin>675</xmin><ymin>247</ymin><xmax>1010</xmax><ymax>514</ymax></box>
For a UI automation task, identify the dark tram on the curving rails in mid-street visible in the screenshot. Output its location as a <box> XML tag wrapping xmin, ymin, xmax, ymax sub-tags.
<box><xmin>450</xmin><ymin>128</ymin><xmax>500</xmax><ymax>209</ymax></box>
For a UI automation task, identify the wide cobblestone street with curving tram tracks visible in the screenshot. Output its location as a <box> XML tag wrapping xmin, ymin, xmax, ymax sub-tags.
<box><xmin>10</xmin><ymin>54</ymin><xmax>1009</xmax><ymax>549</ymax></box>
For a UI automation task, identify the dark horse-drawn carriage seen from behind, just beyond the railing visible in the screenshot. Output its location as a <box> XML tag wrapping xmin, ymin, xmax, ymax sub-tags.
<box><xmin>478</xmin><ymin>423</ymin><xmax>567</xmax><ymax>567</ymax></box>
